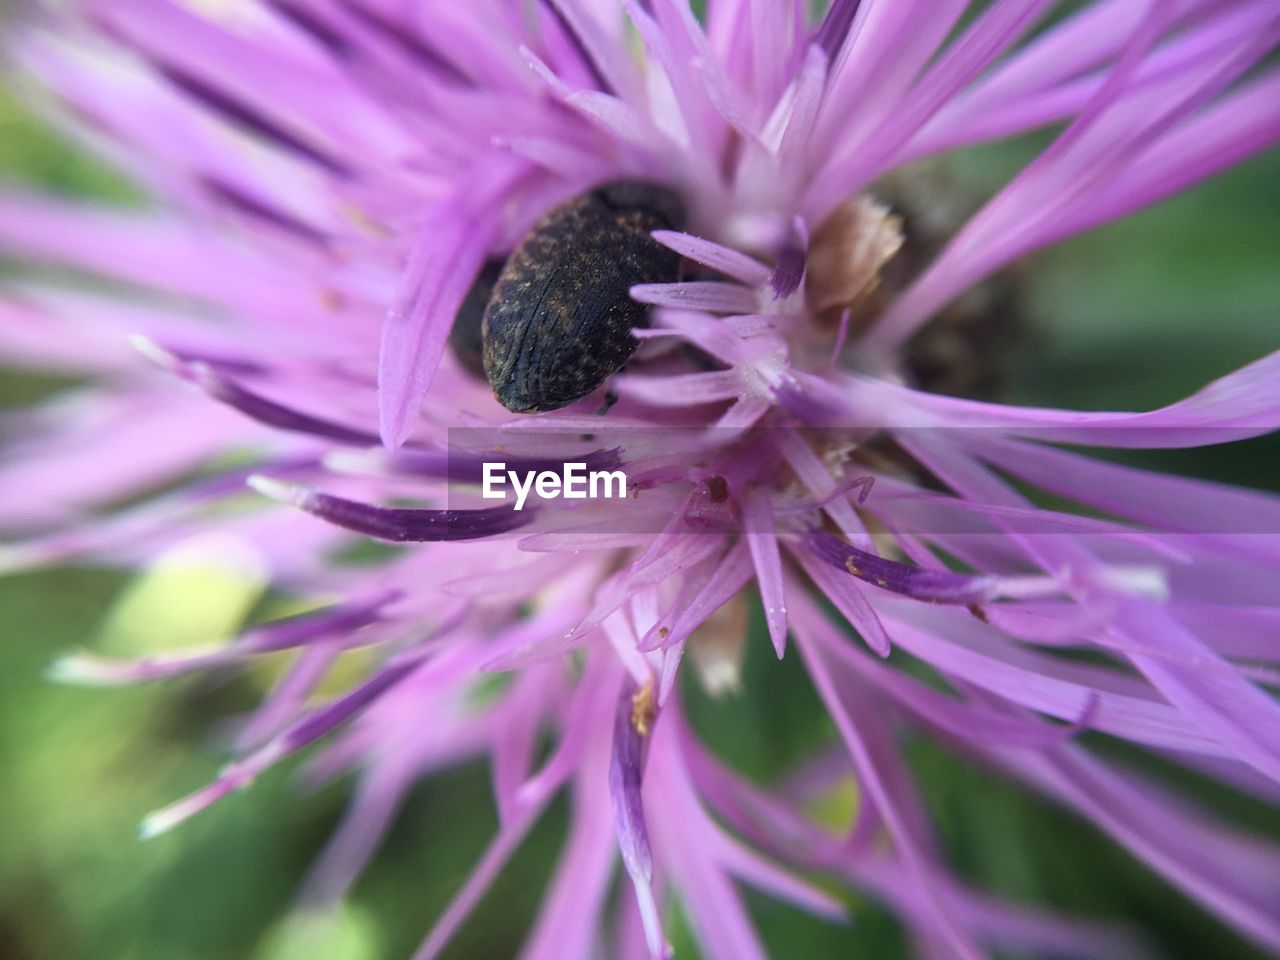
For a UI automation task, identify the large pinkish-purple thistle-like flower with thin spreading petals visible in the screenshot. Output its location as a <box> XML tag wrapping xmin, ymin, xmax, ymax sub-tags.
<box><xmin>0</xmin><ymin>0</ymin><xmax>1280</xmax><ymax>960</ymax></box>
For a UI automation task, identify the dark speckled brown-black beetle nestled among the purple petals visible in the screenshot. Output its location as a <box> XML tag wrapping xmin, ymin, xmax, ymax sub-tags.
<box><xmin>484</xmin><ymin>180</ymin><xmax>685</xmax><ymax>413</ymax></box>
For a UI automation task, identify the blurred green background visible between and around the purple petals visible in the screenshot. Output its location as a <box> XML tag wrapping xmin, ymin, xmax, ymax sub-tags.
<box><xmin>0</xmin><ymin>48</ymin><xmax>1280</xmax><ymax>960</ymax></box>
